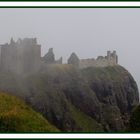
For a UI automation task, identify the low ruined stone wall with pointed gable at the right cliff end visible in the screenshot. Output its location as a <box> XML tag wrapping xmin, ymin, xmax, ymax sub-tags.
<box><xmin>68</xmin><ymin>51</ymin><xmax>118</xmax><ymax>69</ymax></box>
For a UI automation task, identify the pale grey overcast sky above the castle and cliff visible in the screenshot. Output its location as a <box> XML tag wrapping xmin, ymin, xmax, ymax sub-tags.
<box><xmin>0</xmin><ymin>8</ymin><xmax>140</xmax><ymax>92</ymax></box>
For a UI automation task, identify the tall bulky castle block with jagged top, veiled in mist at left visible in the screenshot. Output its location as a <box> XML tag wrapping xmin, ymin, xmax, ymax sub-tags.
<box><xmin>0</xmin><ymin>38</ymin><xmax>41</xmax><ymax>74</ymax></box>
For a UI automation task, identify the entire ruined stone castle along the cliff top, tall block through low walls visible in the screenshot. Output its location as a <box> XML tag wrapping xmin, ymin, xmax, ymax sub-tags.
<box><xmin>0</xmin><ymin>38</ymin><xmax>118</xmax><ymax>74</ymax></box>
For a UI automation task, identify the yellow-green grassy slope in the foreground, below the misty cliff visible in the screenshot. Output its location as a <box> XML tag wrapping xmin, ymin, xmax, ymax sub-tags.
<box><xmin>0</xmin><ymin>93</ymin><xmax>58</xmax><ymax>132</ymax></box>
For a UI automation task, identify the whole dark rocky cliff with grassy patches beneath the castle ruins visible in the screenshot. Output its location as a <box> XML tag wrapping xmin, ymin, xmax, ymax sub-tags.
<box><xmin>0</xmin><ymin>64</ymin><xmax>139</xmax><ymax>132</ymax></box>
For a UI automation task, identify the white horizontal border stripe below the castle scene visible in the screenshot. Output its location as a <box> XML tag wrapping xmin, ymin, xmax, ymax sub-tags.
<box><xmin>0</xmin><ymin>133</ymin><xmax>140</xmax><ymax>139</ymax></box>
